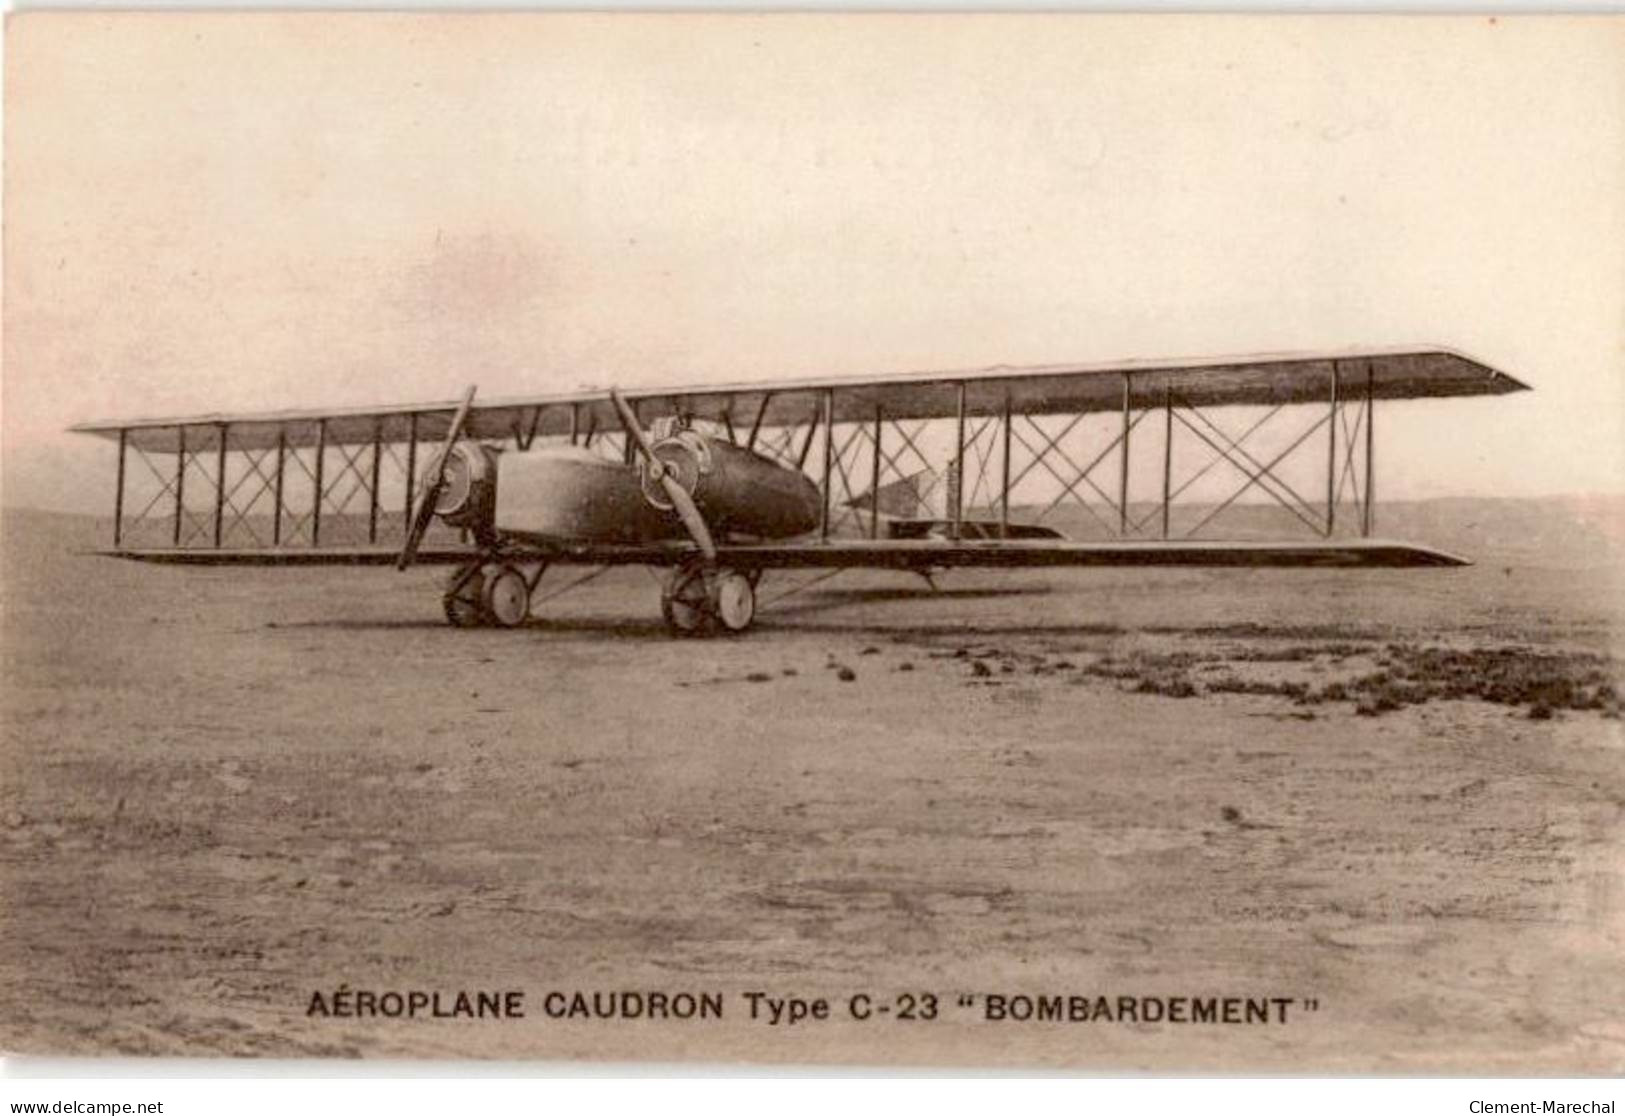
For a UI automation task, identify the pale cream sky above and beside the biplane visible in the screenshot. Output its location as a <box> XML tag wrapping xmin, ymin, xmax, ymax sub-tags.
<box><xmin>0</xmin><ymin>13</ymin><xmax>1625</xmax><ymax>512</ymax></box>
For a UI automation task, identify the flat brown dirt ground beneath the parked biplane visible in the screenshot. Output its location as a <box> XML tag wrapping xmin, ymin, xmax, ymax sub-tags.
<box><xmin>0</xmin><ymin>515</ymin><xmax>1625</xmax><ymax>1074</ymax></box>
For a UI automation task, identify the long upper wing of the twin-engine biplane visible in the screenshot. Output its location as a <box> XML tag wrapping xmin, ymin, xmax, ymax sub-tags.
<box><xmin>72</xmin><ymin>349</ymin><xmax>1528</xmax><ymax>453</ymax></box>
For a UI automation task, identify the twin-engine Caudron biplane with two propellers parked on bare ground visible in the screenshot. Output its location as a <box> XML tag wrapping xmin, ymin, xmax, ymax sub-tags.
<box><xmin>73</xmin><ymin>349</ymin><xmax>1528</xmax><ymax>635</ymax></box>
